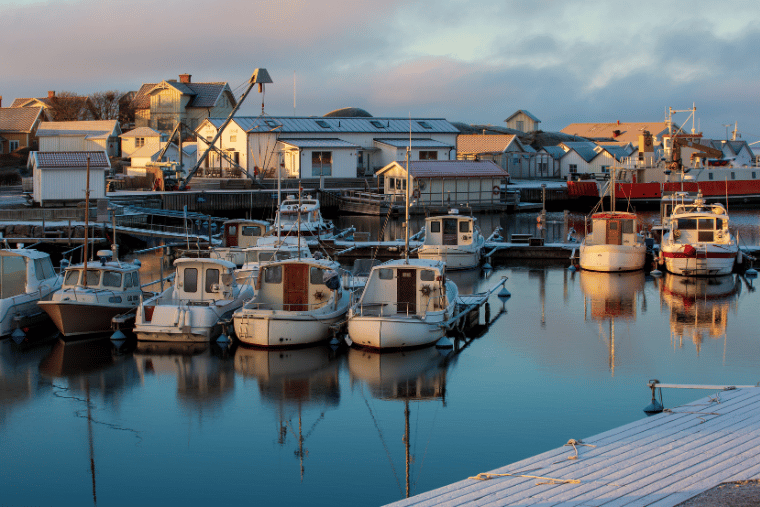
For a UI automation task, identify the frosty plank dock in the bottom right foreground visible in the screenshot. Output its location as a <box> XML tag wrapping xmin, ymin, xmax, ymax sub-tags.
<box><xmin>392</xmin><ymin>387</ymin><xmax>760</xmax><ymax>507</ymax></box>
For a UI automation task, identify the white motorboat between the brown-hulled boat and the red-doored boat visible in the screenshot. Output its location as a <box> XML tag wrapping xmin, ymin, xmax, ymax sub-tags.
<box><xmin>134</xmin><ymin>258</ymin><xmax>254</xmax><ymax>342</ymax></box>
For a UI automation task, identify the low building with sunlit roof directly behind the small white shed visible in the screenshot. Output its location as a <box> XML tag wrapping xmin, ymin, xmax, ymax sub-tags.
<box><xmin>37</xmin><ymin>120</ymin><xmax>121</xmax><ymax>157</ymax></box>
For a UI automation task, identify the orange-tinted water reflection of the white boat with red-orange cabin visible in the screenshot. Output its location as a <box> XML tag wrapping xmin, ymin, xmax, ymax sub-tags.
<box><xmin>580</xmin><ymin>271</ymin><xmax>646</xmax><ymax>375</ymax></box>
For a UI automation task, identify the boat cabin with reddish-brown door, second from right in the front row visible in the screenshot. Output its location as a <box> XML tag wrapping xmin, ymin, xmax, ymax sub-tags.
<box><xmin>254</xmin><ymin>259</ymin><xmax>342</xmax><ymax>312</ymax></box>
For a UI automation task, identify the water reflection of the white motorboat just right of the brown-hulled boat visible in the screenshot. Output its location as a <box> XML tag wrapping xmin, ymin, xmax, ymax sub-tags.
<box><xmin>133</xmin><ymin>341</ymin><xmax>235</xmax><ymax>413</ymax></box>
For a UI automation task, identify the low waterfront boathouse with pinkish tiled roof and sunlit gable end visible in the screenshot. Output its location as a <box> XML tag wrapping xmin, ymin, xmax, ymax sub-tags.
<box><xmin>377</xmin><ymin>160</ymin><xmax>509</xmax><ymax>206</ymax></box>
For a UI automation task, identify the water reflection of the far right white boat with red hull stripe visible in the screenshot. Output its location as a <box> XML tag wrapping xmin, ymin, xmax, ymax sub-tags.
<box><xmin>660</xmin><ymin>273</ymin><xmax>741</xmax><ymax>354</ymax></box>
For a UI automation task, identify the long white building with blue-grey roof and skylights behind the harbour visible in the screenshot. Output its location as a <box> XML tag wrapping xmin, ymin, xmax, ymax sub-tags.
<box><xmin>196</xmin><ymin>116</ymin><xmax>459</xmax><ymax>179</ymax></box>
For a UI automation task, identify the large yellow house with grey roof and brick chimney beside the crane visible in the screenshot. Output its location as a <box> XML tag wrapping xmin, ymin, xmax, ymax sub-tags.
<box><xmin>132</xmin><ymin>74</ymin><xmax>237</xmax><ymax>134</ymax></box>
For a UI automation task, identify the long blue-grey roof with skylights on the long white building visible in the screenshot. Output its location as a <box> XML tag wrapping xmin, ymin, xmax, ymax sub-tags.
<box><xmin>207</xmin><ymin>116</ymin><xmax>459</xmax><ymax>135</ymax></box>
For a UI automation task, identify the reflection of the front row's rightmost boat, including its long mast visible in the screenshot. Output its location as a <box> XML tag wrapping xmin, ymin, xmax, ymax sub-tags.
<box><xmin>348</xmin><ymin>347</ymin><xmax>456</xmax><ymax>498</ymax></box>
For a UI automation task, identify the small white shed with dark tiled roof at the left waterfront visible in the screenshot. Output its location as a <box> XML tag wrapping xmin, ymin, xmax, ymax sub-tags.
<box><xmin>27</xmin><ymin>151</ymin><xmax>111</xmax><ymax>206</ymax></box>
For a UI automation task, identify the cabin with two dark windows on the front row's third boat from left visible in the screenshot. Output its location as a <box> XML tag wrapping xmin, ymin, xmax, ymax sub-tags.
<box><xmin>172</xmin><ymin>257</ymin><xmax>236</xmax><ymax>305</ymax></box>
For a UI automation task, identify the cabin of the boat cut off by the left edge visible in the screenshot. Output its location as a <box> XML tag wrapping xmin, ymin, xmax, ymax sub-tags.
<box><xmin>0</xmin><ymin>248</ymin><xmax>56</xmax><ymax>299</ymax></box>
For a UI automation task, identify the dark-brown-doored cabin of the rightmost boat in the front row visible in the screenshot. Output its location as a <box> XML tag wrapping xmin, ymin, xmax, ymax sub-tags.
<box><xmin>359</xmin><ymin>259</ymin><xmax>448</xmax><ymax>316</ymax></box>
